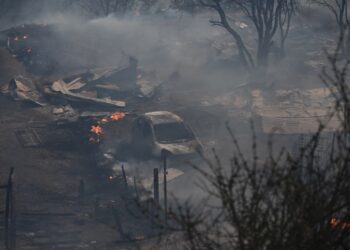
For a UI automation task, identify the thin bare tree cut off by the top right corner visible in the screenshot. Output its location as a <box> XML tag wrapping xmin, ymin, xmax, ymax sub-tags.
<box><xmin>311</xmin><ymin>0</ymin><xmax>350</xmax><ymax>56</ymax></box>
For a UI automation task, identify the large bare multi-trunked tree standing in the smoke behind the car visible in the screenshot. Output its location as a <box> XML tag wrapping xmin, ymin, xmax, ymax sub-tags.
<box><xmin>199</xmin><ymin>0</ymin><xmax>296</xmax><ymax>69</ymax></box>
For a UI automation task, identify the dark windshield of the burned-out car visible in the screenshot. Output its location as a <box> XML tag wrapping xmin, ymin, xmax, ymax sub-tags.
<box><xmin>154</xmin><ymin>122</ymin><xmax>194</xmax><ymax>143</ymax></box>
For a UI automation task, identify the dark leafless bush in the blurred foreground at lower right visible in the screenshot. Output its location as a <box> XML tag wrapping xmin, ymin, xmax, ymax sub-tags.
<box><xmin>159</xmin><ymin>35</ymin><xmax>350</xmax><ymax>250</ymax></box>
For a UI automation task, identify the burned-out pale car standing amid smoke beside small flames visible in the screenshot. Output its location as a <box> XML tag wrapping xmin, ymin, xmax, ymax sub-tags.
<box><xmin>131</xmin><ymin>111</ymin><xmax>202</xmax><ymax>157</ymax></box>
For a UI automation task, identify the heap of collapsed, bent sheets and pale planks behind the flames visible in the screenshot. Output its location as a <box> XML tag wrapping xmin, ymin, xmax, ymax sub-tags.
<box><xmin>0</xmin><ymin>57</ymin><xmax>160</xmax><ymax>122</ymax></box>
